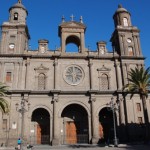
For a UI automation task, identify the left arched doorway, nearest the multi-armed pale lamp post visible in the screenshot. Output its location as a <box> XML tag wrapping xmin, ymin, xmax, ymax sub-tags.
<box><xmin>31</xmin><ymin>108</ymin><xmax>50</xmax><ymax>144</ymax></box>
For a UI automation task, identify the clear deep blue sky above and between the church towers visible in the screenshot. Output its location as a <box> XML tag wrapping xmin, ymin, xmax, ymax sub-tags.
<box><xmin>0</xmin><ymin>0</ymin><xmax>150</xmax><ymax>67</ymax></box>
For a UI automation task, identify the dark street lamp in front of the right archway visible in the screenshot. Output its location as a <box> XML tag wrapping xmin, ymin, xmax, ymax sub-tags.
<box><xmin>107</xmin><ymin>97</ymin><xmax>118</xmax><ymax>147</ymax></box>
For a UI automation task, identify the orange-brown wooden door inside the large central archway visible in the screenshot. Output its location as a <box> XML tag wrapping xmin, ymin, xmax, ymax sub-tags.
<box><xmin>66</xmin><ymin>121</ymin><xmax>77</xmax><ymax>144</ymax></box>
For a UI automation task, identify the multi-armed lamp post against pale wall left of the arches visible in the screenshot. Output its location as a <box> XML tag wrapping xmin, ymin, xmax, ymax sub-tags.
<box><xmin>16</xmin><ymin>93</ymin><xmax>30</xmax><ymax>142</ymax></box>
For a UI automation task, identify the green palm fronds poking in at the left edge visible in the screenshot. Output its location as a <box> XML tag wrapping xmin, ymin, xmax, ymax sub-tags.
<box><xmin>0</xmin><ymin>83</ymin><xmax>9</xmax><ymax>113</ymax></box>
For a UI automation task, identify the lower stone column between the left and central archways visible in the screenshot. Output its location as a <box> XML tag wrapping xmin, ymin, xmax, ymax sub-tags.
<box><xmin>52</xmin><ymin>94</ymin><xmax>60</xmax><ymax>145</ymax></box>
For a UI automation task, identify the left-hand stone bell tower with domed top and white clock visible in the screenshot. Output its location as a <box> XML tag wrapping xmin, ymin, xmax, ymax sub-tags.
<box><xmin>0</xmin><ymin>0</ymin><xmax>30</xmax><ymax>54</ymax></box>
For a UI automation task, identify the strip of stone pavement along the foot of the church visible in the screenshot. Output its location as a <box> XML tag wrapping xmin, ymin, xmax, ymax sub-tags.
<box><xmin>0</xmin><ymin>144</ymin><xmax>150</xmax><ymax>150</ymax></box>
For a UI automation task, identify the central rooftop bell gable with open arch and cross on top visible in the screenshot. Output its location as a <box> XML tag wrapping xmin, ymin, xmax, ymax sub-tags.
<box><xmin>58</xmin><ymin>15</ymin><xmax>86</xmax><ymax>53</ymax></box>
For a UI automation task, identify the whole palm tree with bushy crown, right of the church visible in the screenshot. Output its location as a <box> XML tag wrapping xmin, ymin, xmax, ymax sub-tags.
<box><xmin>124</xmin><ymin>67</ymin><xmax>150</xmax><ymax>141</ymax></box>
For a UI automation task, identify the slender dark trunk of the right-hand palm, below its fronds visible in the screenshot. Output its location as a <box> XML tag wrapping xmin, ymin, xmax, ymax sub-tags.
<box><xmin>141</xmin><ymin>95</ymin><xmax>149</xmax><ymax>143</ymax></box>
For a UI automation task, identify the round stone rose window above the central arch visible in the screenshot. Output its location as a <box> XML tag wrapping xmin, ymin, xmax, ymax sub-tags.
<box><xmin>64</xmin><ymin>65</ymin><xmax>83</xmax><ymax>85</ymax></box>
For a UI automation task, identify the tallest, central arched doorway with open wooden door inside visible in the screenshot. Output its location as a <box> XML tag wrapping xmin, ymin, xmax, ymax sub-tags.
<box><xmin>61</xmin><ymin>104</ymin><xmax>89</xmax><ymax>144</ymax></box>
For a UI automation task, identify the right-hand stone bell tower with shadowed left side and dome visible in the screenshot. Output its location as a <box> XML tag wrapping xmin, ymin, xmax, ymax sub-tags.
<box><xmin>111</xmin><ymin>5</ymin><xmax>142</xmax><ymax>57</ymax></box>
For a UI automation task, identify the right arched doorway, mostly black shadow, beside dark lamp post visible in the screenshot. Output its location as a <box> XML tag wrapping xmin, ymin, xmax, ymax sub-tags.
<box><xmin>99</xmin><ymin>107</ymin><xmax>116</xmax><ymax>144</ymax></box>
